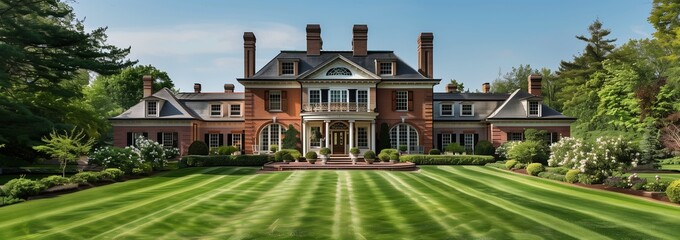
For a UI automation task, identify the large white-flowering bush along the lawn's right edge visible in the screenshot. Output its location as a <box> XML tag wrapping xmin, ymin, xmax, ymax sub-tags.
<box><xmin>548</xmin><ymin>137</ymin><xmax>640</xmax><ymax>183</ymax></box>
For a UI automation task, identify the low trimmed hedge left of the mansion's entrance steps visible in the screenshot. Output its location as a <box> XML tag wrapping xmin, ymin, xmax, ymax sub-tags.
<box><xmin>179</xmin><ymin>155</ymin><xmax>274</xmax><ymax>167</ymax></box>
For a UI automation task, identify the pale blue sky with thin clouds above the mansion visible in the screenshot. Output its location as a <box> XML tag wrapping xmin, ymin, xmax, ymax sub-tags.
<box><xmin>71</xmin><ymin>0</ymin><xmax>654</xmax><ymax>92</ymax></box>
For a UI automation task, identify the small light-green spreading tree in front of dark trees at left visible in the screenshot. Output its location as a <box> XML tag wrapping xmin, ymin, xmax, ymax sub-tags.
<box><xmin>33</xmin><ymin>128</ymin><xmax>94</xmax><ymax>177</ymax></box>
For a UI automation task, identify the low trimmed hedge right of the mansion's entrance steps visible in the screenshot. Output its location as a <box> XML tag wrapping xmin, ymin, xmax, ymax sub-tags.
<box><xmin>400</xmin><ymin>154</ymin><xmax>495</xmax><ymax>165</ymax></box>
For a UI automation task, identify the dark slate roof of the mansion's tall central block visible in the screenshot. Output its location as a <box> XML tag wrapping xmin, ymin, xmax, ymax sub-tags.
<box><xmin>250</xmin><ymin>51</ymin><xmax>430</xmax><ymax>80</ymax></box>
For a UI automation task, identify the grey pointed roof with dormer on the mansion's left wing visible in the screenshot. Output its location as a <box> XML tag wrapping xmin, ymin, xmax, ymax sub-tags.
<box><xmin>111</xmin><ymin>88</ymin><xmax>200</xmax><ymax>120</ymax></box>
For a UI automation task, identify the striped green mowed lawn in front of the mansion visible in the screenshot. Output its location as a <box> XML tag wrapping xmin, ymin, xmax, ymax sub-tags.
<box><xmin>0</xmin><ymin>166</ymin><xmax>680</xmax><ymax>239</ymax></box>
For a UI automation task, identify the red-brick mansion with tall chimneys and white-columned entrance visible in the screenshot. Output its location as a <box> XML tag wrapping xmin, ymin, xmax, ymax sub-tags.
<box><xmin>110</xmin><ymin>24</ymin><xmax>575</xmax><ymax>156</ymax></box>
